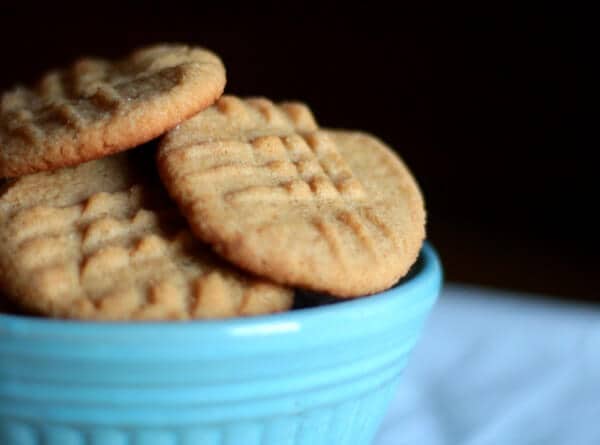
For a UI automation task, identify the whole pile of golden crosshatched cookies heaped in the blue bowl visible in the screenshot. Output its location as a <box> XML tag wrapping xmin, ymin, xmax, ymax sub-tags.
<box><xmin>0</xmin><ymin>45</ymin><xmax>425</xmax><ymax>320</ymax></box>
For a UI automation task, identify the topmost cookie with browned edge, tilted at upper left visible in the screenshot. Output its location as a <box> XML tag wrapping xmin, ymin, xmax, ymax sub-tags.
<box><xmin>0</xmin><ymin>45</ymin><xmax>225</xmax><ymax>177</ymax></box>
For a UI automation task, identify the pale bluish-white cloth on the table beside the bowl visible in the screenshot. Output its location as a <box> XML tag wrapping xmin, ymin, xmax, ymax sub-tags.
<box><xmin>375</xmin><ymin>285</ymin><xmax>600</xmax><ymax>445</ymax></box>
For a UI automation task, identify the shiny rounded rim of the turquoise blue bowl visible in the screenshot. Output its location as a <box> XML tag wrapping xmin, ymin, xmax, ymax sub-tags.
<box><xmin>0</xmin><ymin>241</ymin><xmax>442</xmax><ymax>338</ymax></box>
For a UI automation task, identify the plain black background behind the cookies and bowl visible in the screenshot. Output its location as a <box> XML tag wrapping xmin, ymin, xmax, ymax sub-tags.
<box><xmin>0</xmin><ymin>2</ymin><xmax>600</xmax><ymax>301</ymax></box>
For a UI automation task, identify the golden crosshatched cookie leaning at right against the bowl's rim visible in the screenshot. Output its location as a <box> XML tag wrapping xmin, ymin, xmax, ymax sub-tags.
<box><xmin>157</xmin><ymin>97</ymin><xmax>425</xmax><ymax>297</ymax></box>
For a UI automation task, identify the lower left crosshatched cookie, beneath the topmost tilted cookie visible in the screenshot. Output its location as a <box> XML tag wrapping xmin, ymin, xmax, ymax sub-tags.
<box><xmin>0</xmin><ymin>149</ymin><xmax>293</xmax><ymax>320</ymax></box>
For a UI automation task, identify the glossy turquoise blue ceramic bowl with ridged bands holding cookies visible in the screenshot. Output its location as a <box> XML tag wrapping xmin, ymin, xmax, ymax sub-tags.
<box><xmin>0</xmin><ymin>245</ymin><xmax>441</xmax><ymax>445</ymax></box>
